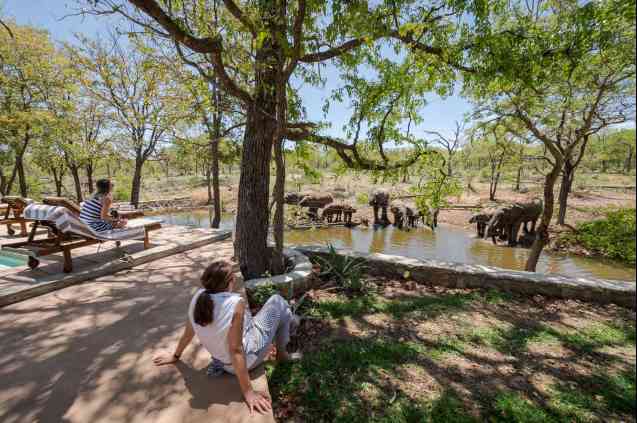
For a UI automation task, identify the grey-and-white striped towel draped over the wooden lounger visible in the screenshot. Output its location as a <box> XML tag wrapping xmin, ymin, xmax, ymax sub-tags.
<box><xmin>24</xmin><ymin>204</ymin><xmax>154</xmax><ymax>241</ymax></box>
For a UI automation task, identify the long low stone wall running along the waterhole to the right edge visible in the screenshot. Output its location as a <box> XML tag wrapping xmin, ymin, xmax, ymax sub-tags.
<box><xmin>296</xmin><ymin>246</ymin><xmax>636</xmax><ymax>309</ymax></box>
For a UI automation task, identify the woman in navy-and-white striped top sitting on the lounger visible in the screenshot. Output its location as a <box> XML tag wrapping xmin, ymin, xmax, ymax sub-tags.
<box><xmin>80</xmin><ymin>179</ymin><xmax>127</xmax><ymax>232</ymax></box>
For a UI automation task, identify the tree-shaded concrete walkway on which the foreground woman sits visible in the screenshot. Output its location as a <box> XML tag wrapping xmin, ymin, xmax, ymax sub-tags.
<box><xmin>0</xmin><ymin>241</ymin><xmax>274</xmax><ymax>423</ymax></box>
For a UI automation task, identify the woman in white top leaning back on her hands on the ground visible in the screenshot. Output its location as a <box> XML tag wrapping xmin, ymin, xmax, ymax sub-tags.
<box><xmin>154</xmin><ymin>260</ymin><xmax>299</xmax><ymax>413</ymax></box>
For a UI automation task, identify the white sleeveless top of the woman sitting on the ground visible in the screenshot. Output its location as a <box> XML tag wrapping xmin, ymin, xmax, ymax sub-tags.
<box><xmin>188</xmin><ymin>289</ymin><xmax>255</xmax><ymax>368</ymax></box>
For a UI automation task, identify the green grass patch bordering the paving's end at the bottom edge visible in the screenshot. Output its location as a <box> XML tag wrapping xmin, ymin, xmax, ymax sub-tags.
<box><xmin>268</xmin><ymin>339</ymin><xmax>474</xmax><ymax>423</ymax></box>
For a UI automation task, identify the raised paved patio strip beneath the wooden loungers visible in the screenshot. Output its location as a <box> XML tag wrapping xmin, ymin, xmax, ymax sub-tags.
<box><xmin>0</xmin><ymin>225</ymin><xmax>230</xmax><ymax>307</ymax></box>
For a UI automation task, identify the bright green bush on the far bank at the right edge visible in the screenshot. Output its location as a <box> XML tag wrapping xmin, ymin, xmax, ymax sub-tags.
<box><xmin>576</xmin><ymin>209</ymin><xmax>635</xmax><ymax>264</ymax></box>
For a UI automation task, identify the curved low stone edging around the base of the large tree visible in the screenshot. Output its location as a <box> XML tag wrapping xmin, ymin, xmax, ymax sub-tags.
<box><xmin>245</xmin><ymin>248</ymin><xmax>312</xmax><ymax>298</ymax></box>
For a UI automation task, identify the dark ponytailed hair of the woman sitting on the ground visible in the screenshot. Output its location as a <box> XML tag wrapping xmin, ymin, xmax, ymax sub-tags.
<box><xmin>193</xmin><ymin>260</ymin><xmax>233</xmax><ymax>326</ymax></box>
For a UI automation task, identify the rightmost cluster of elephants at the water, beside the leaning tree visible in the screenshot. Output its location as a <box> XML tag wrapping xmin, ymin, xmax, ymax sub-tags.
<box><xmin>469</xmin><ymin>200</ymin><xmax>543</xmax><ymax>247</ymax></box>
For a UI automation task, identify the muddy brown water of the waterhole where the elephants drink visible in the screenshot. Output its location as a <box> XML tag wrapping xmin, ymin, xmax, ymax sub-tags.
<box><xmin>155</xmin><ymin>210</ymin><xmax>636</xmax><ymax>281</ymax></box>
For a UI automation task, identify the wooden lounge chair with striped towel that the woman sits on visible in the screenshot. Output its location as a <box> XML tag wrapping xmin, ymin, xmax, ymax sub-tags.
<box><xmin>2</xmin><ymin>204</ymin><xmax>161</xmax><ymax>273</ymax></box>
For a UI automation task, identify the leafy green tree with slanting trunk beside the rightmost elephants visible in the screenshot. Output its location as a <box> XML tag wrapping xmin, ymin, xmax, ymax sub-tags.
<box><xmin>467</xmin><ymin>0</ymin><xmax>635</xmax><ymax>271</ymax></box>
